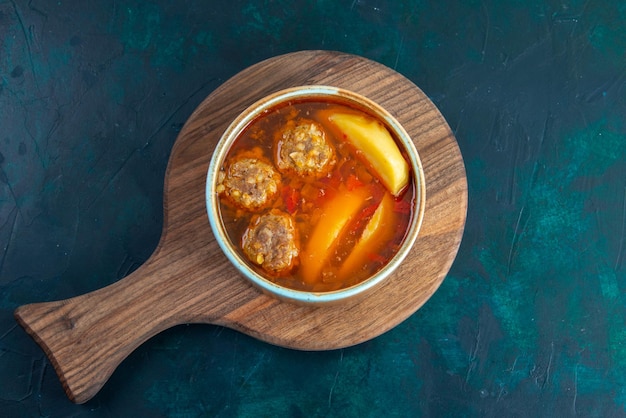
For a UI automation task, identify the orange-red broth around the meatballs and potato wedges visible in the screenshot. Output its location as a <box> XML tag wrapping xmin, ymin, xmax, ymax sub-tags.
<box><xmin>220</xmin><ymin>101</ymin><xmax>415</xmax><ymax>292</ymax></box>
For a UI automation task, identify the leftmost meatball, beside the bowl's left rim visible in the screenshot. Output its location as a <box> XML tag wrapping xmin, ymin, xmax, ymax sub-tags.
<box><xmin>217</xmin><ymin>157</ymin><xmax>280</xmax><ymax>211</ymax></box>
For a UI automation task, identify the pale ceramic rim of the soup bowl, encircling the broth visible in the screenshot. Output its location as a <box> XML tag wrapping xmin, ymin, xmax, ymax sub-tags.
<box><xmin>205</xmin><ymin>85</ymin><xmax>426</xmax><ymax>305</ymax></box>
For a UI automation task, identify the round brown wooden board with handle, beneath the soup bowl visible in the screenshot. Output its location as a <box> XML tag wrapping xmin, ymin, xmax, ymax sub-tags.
<box><xmin>15</xmin><ymin>51</ymin><xmax>467</xmax><ymax>403</ymax></box>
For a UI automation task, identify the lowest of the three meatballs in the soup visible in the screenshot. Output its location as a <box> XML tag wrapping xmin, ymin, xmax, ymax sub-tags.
<box><xmin>241</xmin><ymin>209</ymin><xmax>300</xmax><ymax>276</ymax></box>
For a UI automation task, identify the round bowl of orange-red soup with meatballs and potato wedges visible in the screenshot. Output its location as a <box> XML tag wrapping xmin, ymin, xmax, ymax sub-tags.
<box><xmin>206</xmin><ymin>86</ymin><xmax>425</xmax><ymax>305</ymax></box>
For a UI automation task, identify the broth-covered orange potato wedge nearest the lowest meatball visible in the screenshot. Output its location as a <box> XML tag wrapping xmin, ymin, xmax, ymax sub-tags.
<box><xmin>300</xmin><ymin>187</ymin><xmax>368</xmax><ymax>284</ymax></box>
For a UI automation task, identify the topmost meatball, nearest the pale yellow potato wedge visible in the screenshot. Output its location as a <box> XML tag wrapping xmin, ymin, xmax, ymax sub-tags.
<box><xmin>275</xmin><ymin>119</ymin><xmax>335</xmax><ymax>178</ymax></box>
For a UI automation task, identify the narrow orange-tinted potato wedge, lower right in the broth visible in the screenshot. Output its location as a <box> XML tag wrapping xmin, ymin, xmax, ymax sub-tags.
<box><xmin>337</xmin><ymin>193</ymin><xmax>396</xmax><ymax>280</ymax></box>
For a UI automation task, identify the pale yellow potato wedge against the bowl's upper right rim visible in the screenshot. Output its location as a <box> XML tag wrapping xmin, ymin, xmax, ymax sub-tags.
<box><xmin>328</xmin><ymin>113</ymin><xmax>409</xmax><ymax>196</ymax></box>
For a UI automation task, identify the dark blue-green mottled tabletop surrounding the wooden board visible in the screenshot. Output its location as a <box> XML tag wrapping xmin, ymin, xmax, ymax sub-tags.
<box><xmin>0</xmin><ymin>0</ymin><xmax>626</xmax><ymax>417</ymax></box>
